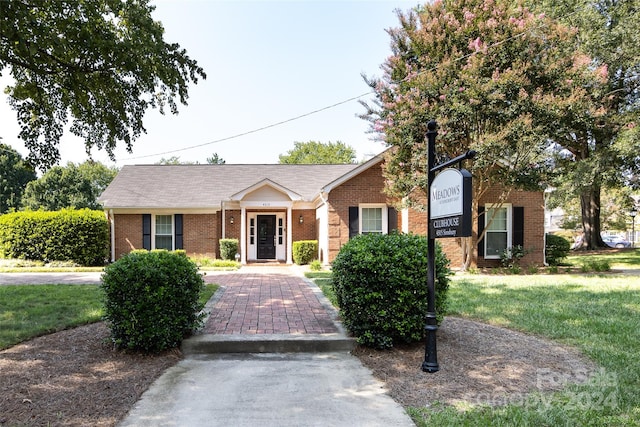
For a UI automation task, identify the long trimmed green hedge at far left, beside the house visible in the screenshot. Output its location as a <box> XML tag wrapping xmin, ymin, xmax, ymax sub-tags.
<box><xmin>0</xmin><ymin>209</ymin><xmax>109</xmax><ymax>266</ymax></box>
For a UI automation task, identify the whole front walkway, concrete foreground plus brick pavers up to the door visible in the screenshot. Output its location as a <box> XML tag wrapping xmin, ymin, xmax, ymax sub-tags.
<box><xmin>120</xmin><ymin>266</ymin><xmax>414</xmax><ymax>427</ymax></box>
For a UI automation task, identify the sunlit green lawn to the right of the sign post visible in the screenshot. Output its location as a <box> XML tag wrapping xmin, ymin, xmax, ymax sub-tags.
<box><xmin>408</xmin><ymin>275</ymin><xmax>640</xmax><ymax>426</ymax></box>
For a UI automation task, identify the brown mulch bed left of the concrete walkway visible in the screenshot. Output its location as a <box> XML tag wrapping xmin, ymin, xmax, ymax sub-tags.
<box><xmin>0</xmin><ymin>323</ymin><xmax>181</xmax><ymax>427</ymax></box>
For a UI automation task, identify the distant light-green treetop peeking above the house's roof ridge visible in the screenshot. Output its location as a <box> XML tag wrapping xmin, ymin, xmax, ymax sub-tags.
<box><xmin>278</xmin><ymin>141</ymin><xmax>356</xmax><ymax>165</ymax></box>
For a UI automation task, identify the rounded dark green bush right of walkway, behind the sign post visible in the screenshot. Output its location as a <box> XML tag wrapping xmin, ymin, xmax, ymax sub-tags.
<box><xmin>333</xmin><ymin>234</ymin><xmax>451</xmax><ymax>348</ymax></box>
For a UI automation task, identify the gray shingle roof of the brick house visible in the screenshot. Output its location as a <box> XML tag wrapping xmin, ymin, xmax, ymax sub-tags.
<box><xmin>98</xmin><ymin>164</ymin><xmax>359</xmax><ymax>209</ymax></box>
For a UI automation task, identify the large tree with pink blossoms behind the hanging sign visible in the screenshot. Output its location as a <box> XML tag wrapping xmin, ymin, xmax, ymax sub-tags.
<box><xmin>363</xmin><ymin>0</ymin><xmax>599</xmax><ymax>267</ymax></box>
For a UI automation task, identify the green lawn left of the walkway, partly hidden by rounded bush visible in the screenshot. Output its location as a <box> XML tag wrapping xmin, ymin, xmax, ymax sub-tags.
<box><xmin>0</xmin><ymin>284</ymin><xmax>218</xmax><ymax>349</ymax></box>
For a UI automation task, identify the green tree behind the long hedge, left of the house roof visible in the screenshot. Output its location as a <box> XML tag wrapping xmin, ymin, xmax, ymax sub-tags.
<box><xmin>22</xmin><ymin>161</ymin><xmax>118</xmax><ymax>211</ymax></box>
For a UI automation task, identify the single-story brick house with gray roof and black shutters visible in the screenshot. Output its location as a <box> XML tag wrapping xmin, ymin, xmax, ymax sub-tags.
<box><xmin>99</xmin><ymin>154</ymin><xmax>544</xmax><ymax>267</ymax></box>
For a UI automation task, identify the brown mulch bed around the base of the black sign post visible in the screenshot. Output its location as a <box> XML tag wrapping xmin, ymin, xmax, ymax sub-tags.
<box><xmin>354</xmin><ymin>317</ymin><xmax>595</xmax><ymax>407</ymax></box>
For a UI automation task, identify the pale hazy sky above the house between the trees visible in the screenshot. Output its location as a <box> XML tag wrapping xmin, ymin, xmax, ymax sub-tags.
<box><xmin>0</xmin><ymin>0</ymin><xmax>420</xmax><ymax>167</ymax></box>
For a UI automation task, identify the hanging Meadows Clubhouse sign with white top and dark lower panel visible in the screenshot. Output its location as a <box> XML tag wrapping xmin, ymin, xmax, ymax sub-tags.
<box><xmin>429</xmin><ymin>168</ymin><xmax>472</xmax><ymax>238</ymax></box>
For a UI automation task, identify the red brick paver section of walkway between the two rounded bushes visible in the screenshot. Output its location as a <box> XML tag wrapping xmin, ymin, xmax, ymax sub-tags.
<box><xmin>204</xmin><ymin>266</ymin><xmax>338</xmax><ymax>334</ymax></box>
